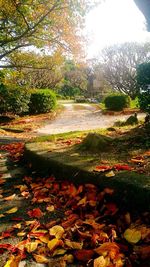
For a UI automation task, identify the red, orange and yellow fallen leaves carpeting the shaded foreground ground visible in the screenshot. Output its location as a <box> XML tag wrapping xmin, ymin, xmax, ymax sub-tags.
<box><xmin>0</xmin><ymin>143</ymin><xmax>150</xmax><ymax>267</ymax></box>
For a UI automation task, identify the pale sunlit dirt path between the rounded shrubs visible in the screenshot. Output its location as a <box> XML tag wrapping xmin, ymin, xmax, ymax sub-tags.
<box><xmin>36</xmin><ymin>103</ymin><xmax>145</xmax><ymax>134</ymax></box>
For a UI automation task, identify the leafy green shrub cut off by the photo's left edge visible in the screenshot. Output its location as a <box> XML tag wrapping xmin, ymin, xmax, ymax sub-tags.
<box><xmin>0</xmin><ymin>85</ymin><xmax>30</xmax><ymax>115</ymax></box>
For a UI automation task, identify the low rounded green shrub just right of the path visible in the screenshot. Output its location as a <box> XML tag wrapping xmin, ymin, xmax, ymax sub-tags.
<box><xmin>104</xmin><ymin>95</ymin><xmax>130</xmax><ymax>111</ymax></box>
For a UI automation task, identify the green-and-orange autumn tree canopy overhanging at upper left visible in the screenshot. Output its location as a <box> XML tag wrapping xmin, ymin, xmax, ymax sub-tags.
<box><xmin>0</xmin><ymin>0</ymin><xmax>92</xmax><ymax>65</ymax></box>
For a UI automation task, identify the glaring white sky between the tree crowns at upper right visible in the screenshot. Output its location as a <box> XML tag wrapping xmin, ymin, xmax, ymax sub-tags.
<box><xmin>86</xmin><ymin>0</ymin><xmax>150</xmax><ymax>58</ymax></box>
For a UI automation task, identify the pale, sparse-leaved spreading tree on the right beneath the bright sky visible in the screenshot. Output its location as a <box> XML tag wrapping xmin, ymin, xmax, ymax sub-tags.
<box><xmin>100</xmin><ymin>43</ymin><xmax>150</xmax><ymax>98</ymax></box>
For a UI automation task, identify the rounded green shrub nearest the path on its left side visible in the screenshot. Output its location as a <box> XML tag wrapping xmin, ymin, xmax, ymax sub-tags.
<box><xmin>29</xmin><ymin>89</ymin><xmax>56</xmax><ymax>114</ymax></box>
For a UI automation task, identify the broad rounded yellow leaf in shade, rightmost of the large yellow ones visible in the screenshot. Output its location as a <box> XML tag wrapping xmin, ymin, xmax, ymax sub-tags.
<box><xmin>124</xmin><ymin>228</ymin><xmax>141</xmax><ymax>244</ymax></box>
